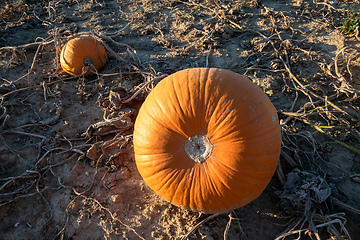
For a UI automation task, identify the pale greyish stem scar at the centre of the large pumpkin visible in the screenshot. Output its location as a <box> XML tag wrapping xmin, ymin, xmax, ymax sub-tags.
<box><xmin>185</xmin><ymin>135</ymin><xmax>214</xmax><ymax>163</ymax></box>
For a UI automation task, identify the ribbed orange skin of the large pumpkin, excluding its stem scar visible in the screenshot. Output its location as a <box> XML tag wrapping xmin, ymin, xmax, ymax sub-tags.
<box><xmin>134</xmin><ymin>68</ymin><xmax>281</xmax><ymax>213</ymax></box>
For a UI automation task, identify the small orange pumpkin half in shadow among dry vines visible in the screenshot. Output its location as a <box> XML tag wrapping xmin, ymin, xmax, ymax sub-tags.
<box><xmin>60</xmin><ymin>36</ymin><xmax>107</xmax><ymax>76</ymax></box>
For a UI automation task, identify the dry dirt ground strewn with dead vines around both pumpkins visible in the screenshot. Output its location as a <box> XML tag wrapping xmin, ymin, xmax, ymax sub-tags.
<box><xmin>0</xmin><ymin>0</ymin><xmax>360</xmax><ymax>240</ymax></box>
